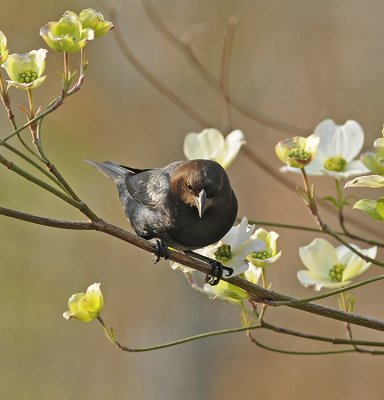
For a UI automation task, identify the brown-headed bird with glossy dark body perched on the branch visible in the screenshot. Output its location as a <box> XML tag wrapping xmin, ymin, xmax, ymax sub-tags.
<box><xmin>86</xmin><ymin>160</ymin><xmax>237</xmax><ymax>282</ymax></box>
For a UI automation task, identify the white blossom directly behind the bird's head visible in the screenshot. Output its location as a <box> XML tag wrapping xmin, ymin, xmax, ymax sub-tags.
<box><xmin>184</xmin><ymin>128</ymin><xmax>245</xmax><ymax>169</ymax></box>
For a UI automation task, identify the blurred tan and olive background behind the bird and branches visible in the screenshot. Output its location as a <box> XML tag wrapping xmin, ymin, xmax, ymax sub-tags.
<box><xmin>0</xmin><ymin>0</ymin><xmax>384</xmax><ymax>400</ymax></box>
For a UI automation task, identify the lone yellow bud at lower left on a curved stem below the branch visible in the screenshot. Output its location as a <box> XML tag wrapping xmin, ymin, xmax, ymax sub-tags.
<box><xmin>63</xmin><ymin>283</ymin><xmax>104</xmax><ymax>322</ymax></box>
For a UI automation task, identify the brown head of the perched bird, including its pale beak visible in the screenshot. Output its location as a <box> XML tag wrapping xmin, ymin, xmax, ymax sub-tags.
<box><xmin>170</xmin><ymin>160</ymin><xmax>232</xmax><ymax>218</ymax></box>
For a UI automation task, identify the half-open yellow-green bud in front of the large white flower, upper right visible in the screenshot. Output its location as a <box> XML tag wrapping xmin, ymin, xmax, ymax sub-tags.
<box><xmin>275</xmin><ymin>135</ymin><xmax>319</xmax><ymax>168</ymax></box>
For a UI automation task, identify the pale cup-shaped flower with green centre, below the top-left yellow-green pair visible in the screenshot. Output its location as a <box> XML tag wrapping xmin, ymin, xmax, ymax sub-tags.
<box><xmin>1</xmin><ymin>49</ymin><xmax>47</xmax><ymax>90</ymax></box>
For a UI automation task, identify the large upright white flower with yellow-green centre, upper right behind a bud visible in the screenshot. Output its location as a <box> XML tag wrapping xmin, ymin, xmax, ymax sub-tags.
<box><xmin>282</xmin><ymin>119</ymin><xmax>369</xmax><ymax>178</ymax></box>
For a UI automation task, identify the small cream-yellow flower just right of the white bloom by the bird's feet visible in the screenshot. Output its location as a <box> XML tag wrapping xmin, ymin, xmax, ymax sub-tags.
<box><xmin>246</xmin><ymin>228</ymin><xmax>281</xmax><ymax>268</ymax></box>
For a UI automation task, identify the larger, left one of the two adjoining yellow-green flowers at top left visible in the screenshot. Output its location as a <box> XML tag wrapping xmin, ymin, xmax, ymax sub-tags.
<box><xmin>40</xmin><ymin>11</ymin><xmax>94</xmax><ymax>53</ymax></box>
